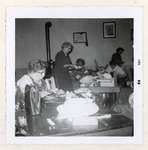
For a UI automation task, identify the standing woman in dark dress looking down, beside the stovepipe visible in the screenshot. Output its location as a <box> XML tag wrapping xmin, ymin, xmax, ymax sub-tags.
<box><xmin>54</xmin><ymin>42</ymin><xmax>73</xmax><ymax>91</ymax></box>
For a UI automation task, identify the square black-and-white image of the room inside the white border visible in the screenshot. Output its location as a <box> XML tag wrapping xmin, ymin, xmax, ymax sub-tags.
<box><xmin>7</xmin><ymin>7</ymin><xmax>141</xmax><ymax>144</ymax></box>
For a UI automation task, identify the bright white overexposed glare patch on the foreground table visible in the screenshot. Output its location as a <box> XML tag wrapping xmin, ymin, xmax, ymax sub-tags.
<box><xmin>57</xmin><ymin>98</ymin><xmax>99</xmax><ymax>126</ymax></box>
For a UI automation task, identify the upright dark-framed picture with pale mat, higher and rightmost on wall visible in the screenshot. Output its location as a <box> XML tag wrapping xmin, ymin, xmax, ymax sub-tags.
<box><xmin>103</xmin><ymin>22</ymin><xmax>116</xmax><ymax>38</ymax></box>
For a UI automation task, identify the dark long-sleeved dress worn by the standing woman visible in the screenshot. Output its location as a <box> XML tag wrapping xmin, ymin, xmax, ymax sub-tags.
<box><xmin>54</xmin><ymin>51</ymin><xmax>73</xmax><ymax>91</ymax></box>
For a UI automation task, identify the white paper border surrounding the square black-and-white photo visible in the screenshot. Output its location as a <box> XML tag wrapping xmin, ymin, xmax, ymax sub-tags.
<box><xmin>6</xmin><ymin>7</ymin><xmax>143</xmax><ymax>144</ymax></box>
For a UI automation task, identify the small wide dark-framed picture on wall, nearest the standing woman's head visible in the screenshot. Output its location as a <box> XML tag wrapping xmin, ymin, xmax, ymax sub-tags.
<box><xmin>73</xmin><ymin>32</ymin><xmax>88</xmax><ymax>46</ymax></box>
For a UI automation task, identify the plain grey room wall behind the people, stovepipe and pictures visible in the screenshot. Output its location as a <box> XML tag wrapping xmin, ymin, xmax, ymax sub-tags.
<box><xmin>16</xmin><ymin>19</ymin><xmax>133</xmax><ymax>68</ymax></box>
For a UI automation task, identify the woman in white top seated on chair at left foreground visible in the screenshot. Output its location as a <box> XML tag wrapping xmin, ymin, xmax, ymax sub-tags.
<box><xmin>16</xmin><ymin>59</ymin><xmax>55</xmax><ymax>135</ymax></box>
